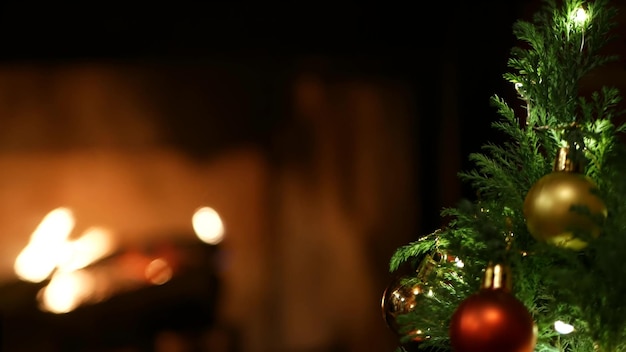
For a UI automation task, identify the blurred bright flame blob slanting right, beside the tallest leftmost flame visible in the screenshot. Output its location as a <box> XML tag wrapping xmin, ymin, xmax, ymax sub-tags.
<box><xmin>58</xmin><ymin>227</ymin><xmax>114</xmax><ymax>271</ymax></box>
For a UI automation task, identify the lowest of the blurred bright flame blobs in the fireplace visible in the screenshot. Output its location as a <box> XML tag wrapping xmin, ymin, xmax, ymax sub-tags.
<box><xmin>40</xmin><ymin>271</ymin><xmax>94</xmax><ymax>314</ymax></box>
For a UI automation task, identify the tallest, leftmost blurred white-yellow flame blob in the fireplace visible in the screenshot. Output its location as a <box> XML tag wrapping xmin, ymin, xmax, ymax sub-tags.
<box><xmin>14</xmin><ymin>208</ymin><xmax>74</xmax><ymax>282</ymax></box>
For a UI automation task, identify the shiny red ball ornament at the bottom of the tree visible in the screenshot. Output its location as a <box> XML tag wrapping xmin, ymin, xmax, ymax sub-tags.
<box><xmin>450</xmin><ymin>289</ymin><xmax>537</xmax><ymax>352</ymax></box>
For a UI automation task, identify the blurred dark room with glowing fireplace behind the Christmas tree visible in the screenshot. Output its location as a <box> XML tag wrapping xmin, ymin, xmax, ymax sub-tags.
<box><xmin>0</xmin><ymin>1</ymin><xmax>623</xmax><ymax>352</ymax></box>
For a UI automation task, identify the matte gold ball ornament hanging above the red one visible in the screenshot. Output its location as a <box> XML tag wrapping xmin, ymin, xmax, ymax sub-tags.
<box><xmin>523</xmin><ymin>171</ymin><xmax>607</xmax><ymax>250</ymax></box>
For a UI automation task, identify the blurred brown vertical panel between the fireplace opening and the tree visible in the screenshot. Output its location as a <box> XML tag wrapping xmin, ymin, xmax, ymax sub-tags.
<box><xmin>272</xmin><ymin>66</ymin><xmax>419</xmax><ymax>352</ymax></box>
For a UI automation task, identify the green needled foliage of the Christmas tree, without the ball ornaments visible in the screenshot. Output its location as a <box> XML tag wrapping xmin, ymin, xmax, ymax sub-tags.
<box><xmin>382</xmin><ymin>0</ymin><xmax>626</xmax><ymax>352</ymax></box>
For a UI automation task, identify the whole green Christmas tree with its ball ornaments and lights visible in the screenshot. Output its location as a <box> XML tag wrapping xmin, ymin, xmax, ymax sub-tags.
<box><xmin>382</xmin><ymin>0</ymin><xmax>626</xmax><ymax>352</ymax></box>
